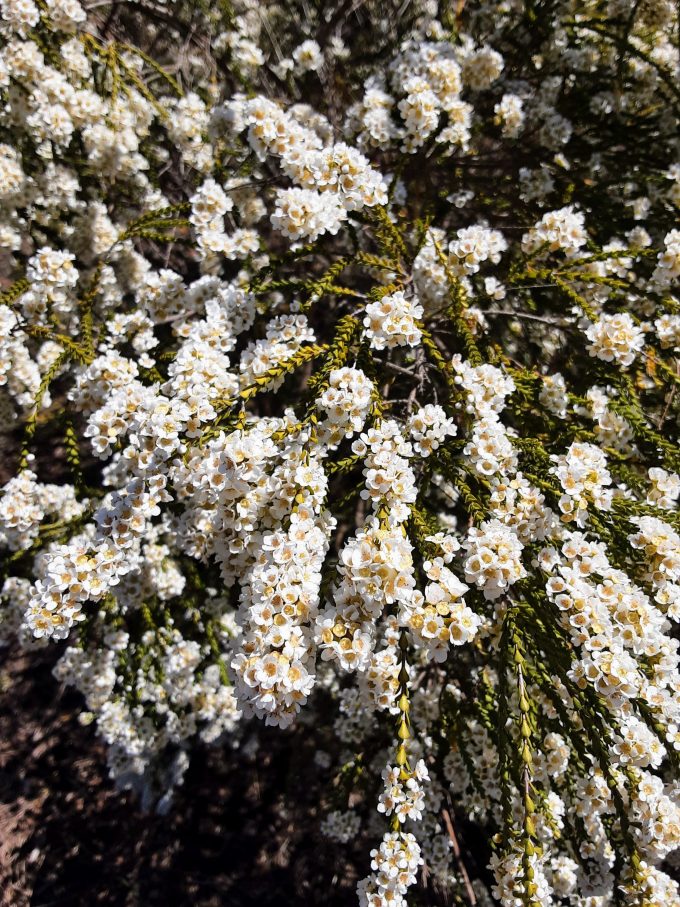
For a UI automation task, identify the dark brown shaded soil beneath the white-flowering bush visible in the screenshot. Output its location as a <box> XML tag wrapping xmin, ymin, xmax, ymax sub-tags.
<box><xmin>0</xmin><ymin>650</ymin><xmax>368</xmax><ymax>907</ymax></box>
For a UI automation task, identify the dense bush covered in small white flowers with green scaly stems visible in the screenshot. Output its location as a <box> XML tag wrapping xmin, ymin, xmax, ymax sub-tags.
<box><xmin>0</xmin><ymin>0</ymin><xmax>680</xmax><ymax>907</ymax></box>
